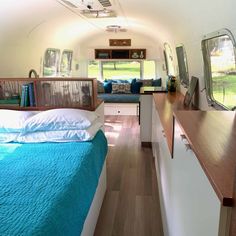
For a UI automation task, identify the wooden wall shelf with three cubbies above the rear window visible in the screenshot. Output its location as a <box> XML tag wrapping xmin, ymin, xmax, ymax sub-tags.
<box><xmin>95</xmin><ymin>49</ymin><xmax>146</xmax><ymax>60</ymax></box>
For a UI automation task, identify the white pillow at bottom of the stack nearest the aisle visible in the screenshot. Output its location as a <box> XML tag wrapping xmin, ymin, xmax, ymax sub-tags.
<box><xmin>15</xmin><ymin>122</ymin><xmax>102</xmax><ymax>143</ymax></box>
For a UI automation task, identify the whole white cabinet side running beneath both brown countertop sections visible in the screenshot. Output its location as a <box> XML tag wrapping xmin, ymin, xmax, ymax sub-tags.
<box><xmin>152</xmin><ymin>98</ymin><xmax>231</xmax><ymax>236</ymax></box>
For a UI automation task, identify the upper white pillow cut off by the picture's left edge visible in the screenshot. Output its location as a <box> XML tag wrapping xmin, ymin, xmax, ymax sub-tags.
<box><xmin>0</xmin><ymin>109</ymin><xmax>36</xmax><ymax>133</ymax></box>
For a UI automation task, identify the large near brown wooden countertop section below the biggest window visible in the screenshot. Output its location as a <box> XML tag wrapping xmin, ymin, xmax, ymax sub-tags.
<box><xmin>174</xmin><ymin>111</ymin><xmax>236</xmax><ymax>206</ymax></box>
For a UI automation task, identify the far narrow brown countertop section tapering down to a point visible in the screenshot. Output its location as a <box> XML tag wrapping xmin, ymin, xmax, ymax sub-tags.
<box><xmin>153</xmin><ymin>92</ymin><xmax>196</xmax><ymax>154</ymax></box>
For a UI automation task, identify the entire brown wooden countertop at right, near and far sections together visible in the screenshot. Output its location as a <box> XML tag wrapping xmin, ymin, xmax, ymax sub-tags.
<box><xmin>153</xmin><ymin>92</ymin><xmax>236</xmax><ymax>206</ymax></box>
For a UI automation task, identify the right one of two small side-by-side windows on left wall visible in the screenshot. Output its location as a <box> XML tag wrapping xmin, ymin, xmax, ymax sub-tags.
<box><xmin>60</xmin><ymin>50</ymin><xmax>73</xmax><ymax>76</ymax></box>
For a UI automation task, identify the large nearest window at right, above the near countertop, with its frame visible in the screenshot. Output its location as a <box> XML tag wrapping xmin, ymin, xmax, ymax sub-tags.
<box><xmin>202</xmin><ymin>29</ymin><xmax>236</xmax><ymax>109</ymax></box>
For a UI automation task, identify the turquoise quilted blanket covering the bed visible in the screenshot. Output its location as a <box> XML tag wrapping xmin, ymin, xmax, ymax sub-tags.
<box><xmin>0</xmin><ymin>131</ymin><xmax>107</xmax><ymax>236</ymax></box>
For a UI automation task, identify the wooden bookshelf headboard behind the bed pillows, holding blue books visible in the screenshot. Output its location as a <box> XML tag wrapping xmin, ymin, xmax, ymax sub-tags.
<box><xmin>0</xmin><ymin>77</ymin><xmax>99</xmax><ymax>110</ymax></box>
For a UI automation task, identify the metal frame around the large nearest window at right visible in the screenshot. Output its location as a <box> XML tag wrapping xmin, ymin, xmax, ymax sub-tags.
<box><xmin>201</xmin><ymin>29</ymin><xmax>236</xmax><ymax>110</ymax></box>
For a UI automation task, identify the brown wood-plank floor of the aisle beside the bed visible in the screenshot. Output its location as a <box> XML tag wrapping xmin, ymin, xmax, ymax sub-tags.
<box><xmin>95</xmin><ymin>116</ymin><xmax>163</xmax><ymax>236</ymax></box>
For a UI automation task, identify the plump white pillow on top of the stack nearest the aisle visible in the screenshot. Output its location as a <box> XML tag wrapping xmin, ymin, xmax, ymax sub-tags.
<box><xmin>24</xmin><ymin>108</ymin><xmax>98</xmax><ymax>133</ymax></box>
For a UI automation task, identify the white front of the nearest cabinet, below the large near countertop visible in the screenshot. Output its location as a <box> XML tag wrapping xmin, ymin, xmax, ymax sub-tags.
<box><xmin>171</xmin><ymin>122</ymin><xmax>221</xmax><ymax>236</ymax></box>
